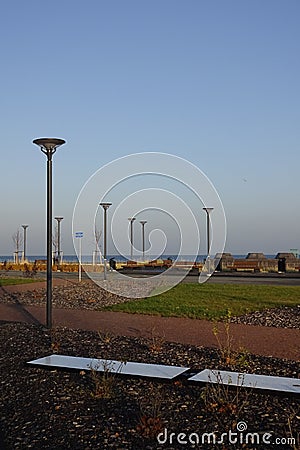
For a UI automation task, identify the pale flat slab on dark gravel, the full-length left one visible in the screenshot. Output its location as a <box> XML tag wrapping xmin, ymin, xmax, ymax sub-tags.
<box><xmin>28</xmin><ymin>354</ymin><xmax>189</xmax><ymax>380</ymax></box>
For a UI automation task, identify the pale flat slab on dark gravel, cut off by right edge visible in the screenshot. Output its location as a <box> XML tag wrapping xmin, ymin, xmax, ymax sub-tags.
<box><xmin>188</xmin><ymin>369</ymin><xmax>300</xmax><ymax>394</ymax></box>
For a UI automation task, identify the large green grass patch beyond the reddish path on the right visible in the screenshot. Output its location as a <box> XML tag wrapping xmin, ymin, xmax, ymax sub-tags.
<box><xmin>106</xmin><ymin>283</ymin><xmax>300</xmax><ymax>320</ymax></box>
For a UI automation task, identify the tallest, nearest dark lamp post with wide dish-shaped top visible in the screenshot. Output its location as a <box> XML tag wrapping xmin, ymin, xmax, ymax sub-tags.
<box><xmin>33</xmin><ymin>138</ymin><xmax>66</xmax><ymax>328</ymax></box>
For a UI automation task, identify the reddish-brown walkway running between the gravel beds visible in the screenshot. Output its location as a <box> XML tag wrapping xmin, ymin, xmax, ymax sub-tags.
<box><xmin>0</xmin><ymin>280</ymin><xmax>300</xmax><ymax>361</ymax></box>
